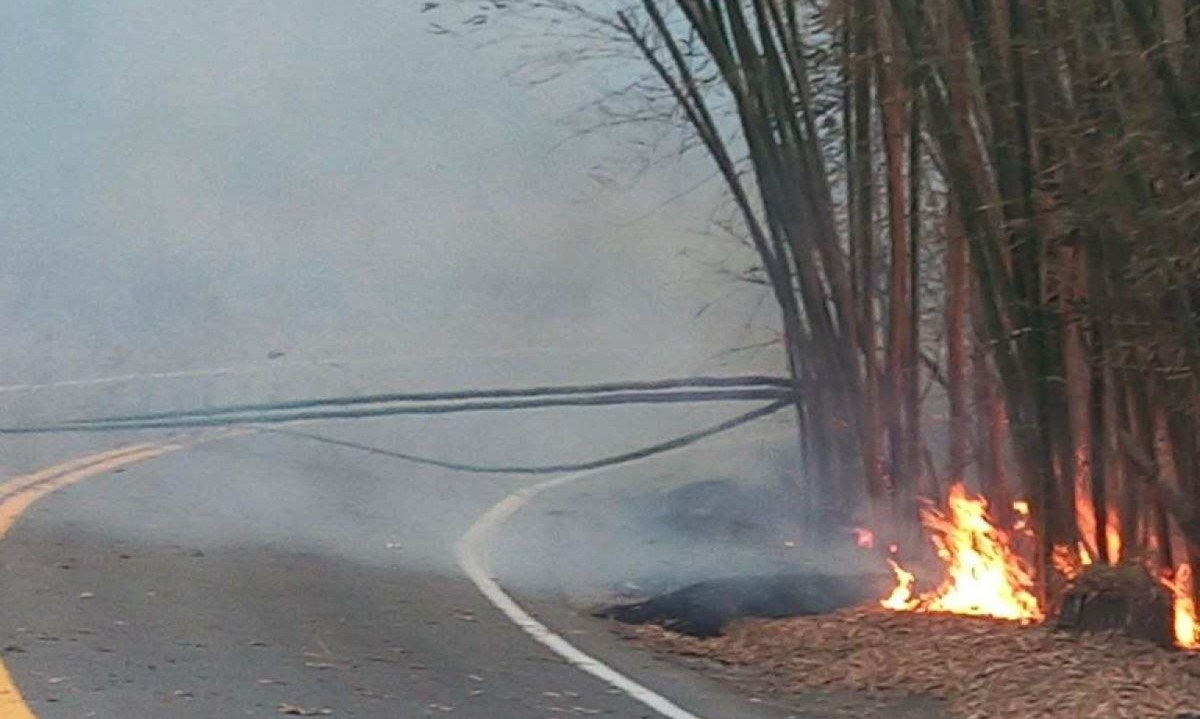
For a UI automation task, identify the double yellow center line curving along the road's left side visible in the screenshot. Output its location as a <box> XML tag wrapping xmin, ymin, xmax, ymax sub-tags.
<box><xmin>0</xmin><ymin>441</ymin><xmax>184</xmax><ymax>719</ymax></box>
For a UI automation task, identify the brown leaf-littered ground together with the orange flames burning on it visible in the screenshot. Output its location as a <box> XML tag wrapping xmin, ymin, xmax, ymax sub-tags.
<box><xmin>609</xmin><ymin>485</ymin><xmax>1200</xmax><ymax>719</ymax></box>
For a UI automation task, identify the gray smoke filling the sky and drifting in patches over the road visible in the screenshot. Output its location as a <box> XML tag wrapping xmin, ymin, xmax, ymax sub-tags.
<box><xmin>0</xmin><ymin>0</ymin><xmax>864</xmax><ymax>602</ymax></box>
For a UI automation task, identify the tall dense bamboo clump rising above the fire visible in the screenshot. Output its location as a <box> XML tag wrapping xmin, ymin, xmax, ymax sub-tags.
<box><xmin>429</xmin><ymin>0</ymin><xmax>1200</xmax><ymax>602</ymax></box>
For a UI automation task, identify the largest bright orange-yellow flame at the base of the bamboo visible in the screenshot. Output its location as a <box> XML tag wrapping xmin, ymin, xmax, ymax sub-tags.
<box><xmin>884</xmin><ymin>484</ymin><xmax>1042</xmax><ymax>622</ymax></box>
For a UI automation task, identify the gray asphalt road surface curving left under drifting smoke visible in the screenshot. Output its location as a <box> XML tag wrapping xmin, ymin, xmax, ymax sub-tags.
<box><xmin>0</xmin><ymin>420</ymin><xmax>825</xmax><ymax>719</ymax></box>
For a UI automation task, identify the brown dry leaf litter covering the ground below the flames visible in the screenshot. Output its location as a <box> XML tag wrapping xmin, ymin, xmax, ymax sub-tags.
<box><xmin>620</xmin><ymin>607</ymin><xmax>1200</xmax><ymax>719</ymax></box>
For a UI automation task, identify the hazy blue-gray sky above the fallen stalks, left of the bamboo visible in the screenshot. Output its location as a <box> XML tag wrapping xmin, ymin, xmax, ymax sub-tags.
<box><xmin>0</xmin><ymin>0</ymin><xmax>769</xmax><ymax>379</ymax></box>
